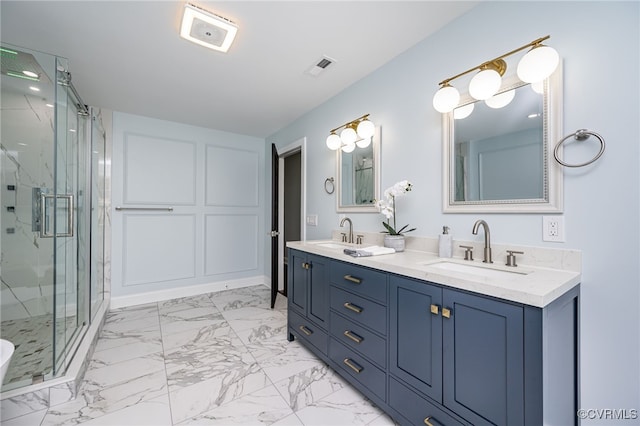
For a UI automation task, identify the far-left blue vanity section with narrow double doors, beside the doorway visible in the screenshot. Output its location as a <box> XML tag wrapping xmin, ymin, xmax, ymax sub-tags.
<box><xmin>287</xmin><ymin>249</ymin><xmax>329</xmax><ymax>355</ymax></box>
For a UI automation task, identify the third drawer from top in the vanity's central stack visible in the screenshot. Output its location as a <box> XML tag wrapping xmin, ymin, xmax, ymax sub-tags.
<box><xmin>331</xmin><ymin>312</ymin><xmax>387</xmax><ymax>368</ymax></box>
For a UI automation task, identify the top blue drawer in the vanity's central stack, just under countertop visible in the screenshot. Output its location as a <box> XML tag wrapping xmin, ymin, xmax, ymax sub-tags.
<box><xmin>331</xmin><ymin>262</ymin><xmax>387</xmax><ymax>305</ymax></box>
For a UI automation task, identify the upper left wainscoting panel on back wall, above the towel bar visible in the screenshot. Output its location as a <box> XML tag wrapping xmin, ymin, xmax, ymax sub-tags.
<box><xmin>124</xmin><ymin>133</ymin><xmax>196</xmax><ymax>205</ymax></box>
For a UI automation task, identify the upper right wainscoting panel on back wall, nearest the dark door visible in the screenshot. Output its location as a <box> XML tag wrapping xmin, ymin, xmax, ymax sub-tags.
<box><xmin>205</xmin><ymin>146</ymin><xmax>260</xmax><ymax>207</ymax></box>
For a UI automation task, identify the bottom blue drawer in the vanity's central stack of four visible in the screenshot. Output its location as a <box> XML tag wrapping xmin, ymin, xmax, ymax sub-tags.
<box><xmin>329</xmin><ymin>338</ymin><xmax>387</xmax><ymax>401</ymax></box>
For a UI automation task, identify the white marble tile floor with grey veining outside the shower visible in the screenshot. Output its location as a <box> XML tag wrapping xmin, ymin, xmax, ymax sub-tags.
<box><xmin>2</xmin><ymin>286</ymin><xmax>394</xmax><ymax>426</ymax></box>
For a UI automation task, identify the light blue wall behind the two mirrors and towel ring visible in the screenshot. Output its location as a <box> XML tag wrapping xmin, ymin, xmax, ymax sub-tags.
<box><xmin>267</xmin><ymin>1</ymin><xmax>640</xmax><ymax>424</ymax></box>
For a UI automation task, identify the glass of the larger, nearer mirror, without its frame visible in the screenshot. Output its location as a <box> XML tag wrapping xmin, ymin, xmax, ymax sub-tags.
<box><xmin>453</xmin><ymin>85</ymin><xmax>544</xmax><ymax>201</ymax></box>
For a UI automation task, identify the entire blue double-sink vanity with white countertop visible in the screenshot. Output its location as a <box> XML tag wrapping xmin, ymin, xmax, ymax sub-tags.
<box><xmin>288</xmin><ymin>242</ymin><xmax>580</xmax><ymax>426</ymax></box>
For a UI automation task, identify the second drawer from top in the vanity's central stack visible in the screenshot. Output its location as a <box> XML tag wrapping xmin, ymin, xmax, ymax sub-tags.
<box><xmin>331</xmin><ymin>287</ymin><xmax>387</xmax><ymax>336</ymax></box>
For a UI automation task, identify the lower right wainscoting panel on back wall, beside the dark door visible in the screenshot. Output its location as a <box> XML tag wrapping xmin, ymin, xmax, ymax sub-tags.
<box><xmin>204</xmin><ymin>214</ymin><xmax>258</xmax><ymax>275</ymax></box>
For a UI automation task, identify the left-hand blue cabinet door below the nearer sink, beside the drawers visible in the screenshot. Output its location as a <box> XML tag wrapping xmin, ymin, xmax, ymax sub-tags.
<box><xmin>389</xmin><ymin>276</ymin><xmax>442</xmax><ymax>402</ymax></box>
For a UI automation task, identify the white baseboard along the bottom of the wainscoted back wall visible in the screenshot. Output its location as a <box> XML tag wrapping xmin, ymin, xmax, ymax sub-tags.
<box><xmin>111</xmin><ymin>275</ymin><xmax>269</xmax><ymax>309</ymax></box>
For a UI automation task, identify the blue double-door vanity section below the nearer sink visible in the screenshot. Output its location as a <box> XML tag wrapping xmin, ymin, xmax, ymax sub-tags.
<box><xmin>389</xmin><ymin>276</ymin><xmax>524</xmax><ymax>425</ymax></box>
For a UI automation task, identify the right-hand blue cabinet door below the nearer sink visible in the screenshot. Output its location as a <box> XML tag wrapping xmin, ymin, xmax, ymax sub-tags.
<box><xmin>442</xmin><ymin>289</ymin><xmax>524</xmax><ymax>426</ymax></box>
